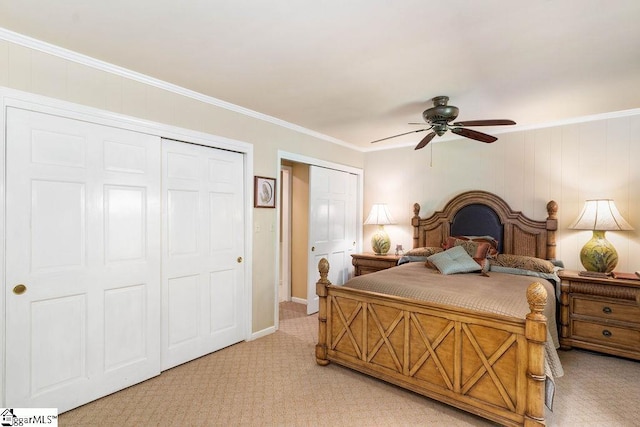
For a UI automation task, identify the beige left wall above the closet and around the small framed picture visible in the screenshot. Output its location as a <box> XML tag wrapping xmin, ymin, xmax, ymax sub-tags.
<box><xmin>0</xmin><ymin>40</ymin><xmax>364</xmax><ymax>332</ymax></box>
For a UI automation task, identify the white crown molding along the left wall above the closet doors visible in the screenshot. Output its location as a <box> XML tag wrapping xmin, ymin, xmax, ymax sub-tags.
<box><xmin>0</xmin><ymin>27</ymin><xmax>362</xmax><ymax>151</ymax></box>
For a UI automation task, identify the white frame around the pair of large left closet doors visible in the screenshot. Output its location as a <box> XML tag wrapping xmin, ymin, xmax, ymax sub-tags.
<box><xmin>0</xmin><ymin>87</ymin><xmax>253</xmax><ymax>405</ymax></box>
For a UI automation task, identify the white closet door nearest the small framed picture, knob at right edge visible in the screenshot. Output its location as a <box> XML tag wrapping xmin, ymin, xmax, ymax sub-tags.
<box><xmin>162</xmin><ymin>140</ymin><xmax>246</xmax><ymax>369</ymax></box>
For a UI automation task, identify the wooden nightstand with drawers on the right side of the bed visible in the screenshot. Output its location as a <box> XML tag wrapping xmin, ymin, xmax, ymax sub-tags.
<box><xmin>558</xmin><ymin>270</ymin><xmax>640</xmax><ymax>360</ymax></box>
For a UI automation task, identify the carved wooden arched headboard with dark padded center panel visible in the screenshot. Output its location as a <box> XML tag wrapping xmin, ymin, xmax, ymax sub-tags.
<box><xmin>411</xmin><ymin>191</ymin><xmax>558</xmax><ymax>260</ymax></box>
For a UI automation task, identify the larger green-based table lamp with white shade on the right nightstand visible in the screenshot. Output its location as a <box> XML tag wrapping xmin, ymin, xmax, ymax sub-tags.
<box><xmin>569</xmin><ymin>199</ymin><xmax>633</xmax><ymax>275</ymax></box>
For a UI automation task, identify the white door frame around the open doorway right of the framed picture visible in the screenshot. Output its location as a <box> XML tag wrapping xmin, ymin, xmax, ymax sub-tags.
<box><xmin>273</xmin><ymin>150</ymin><xmax>364</xmax><ymax>330</ymax></box>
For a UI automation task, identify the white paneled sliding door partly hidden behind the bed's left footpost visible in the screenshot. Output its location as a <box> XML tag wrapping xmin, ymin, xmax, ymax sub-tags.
<box><xmin>307</xmin><ymin>166</ymin><xmax>358</xmax><ymax>314</ymax></box>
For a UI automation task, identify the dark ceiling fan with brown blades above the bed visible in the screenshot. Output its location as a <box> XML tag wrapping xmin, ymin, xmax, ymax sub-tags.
<box><xmin>371</xmin><ymin>96</ymin><xmax>516</xmax><ymax>150</ymax></box>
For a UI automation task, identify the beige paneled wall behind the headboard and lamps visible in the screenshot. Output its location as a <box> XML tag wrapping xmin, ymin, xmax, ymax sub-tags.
<box><xmin>363</xmin><ymin>114</ymin><xmax>640</xmax><ymax>271</ymax></box>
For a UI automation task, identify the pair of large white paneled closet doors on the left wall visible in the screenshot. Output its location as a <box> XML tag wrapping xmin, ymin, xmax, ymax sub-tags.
<box><xmin>4</xmin><ymin>107</ymin><xmax>244</xmax><ymax>412</ymax></box>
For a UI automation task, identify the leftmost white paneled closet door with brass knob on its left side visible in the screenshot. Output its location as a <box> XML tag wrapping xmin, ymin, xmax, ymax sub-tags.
<box><xmin>5</xmin><ymin>108</ymin><xmax>161</xmax><ymax>412</ymax></box>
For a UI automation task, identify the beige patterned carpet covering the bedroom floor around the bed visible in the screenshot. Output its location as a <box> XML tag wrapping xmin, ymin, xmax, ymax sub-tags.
<box><xmin>59</xmin><ymin>303</ymin><xmax>640</xmax><ymax>426</ymax></box>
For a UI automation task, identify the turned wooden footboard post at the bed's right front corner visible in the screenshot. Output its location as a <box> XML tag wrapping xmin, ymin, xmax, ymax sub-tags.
<box><xmin>524</xmin><ymin>282</ymin><xmax>547</xmax><ymax>426</ymax></box>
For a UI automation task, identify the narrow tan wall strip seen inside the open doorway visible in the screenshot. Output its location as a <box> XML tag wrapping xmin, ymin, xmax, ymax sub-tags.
<box><xmin>291</xmin><ymin>163</ymin><xmax>315</xmax><ymax>300</ymax></box>
